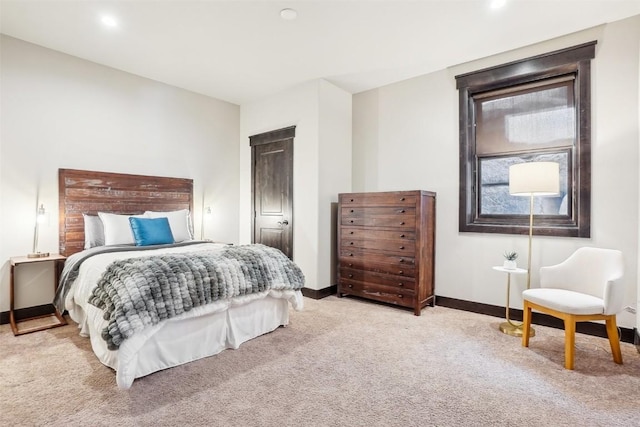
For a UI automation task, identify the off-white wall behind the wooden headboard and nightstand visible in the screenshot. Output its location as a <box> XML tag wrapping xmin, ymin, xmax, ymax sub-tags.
<box><xmin>0</xmin><ymin>36</ymin><xmax>240</xmax><ymax>311</ymax></box>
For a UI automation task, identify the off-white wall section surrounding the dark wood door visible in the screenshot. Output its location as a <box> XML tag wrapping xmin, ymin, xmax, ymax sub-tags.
<box><xmin>240</xmin><ymin>80</ymin><xmax>351</xmax><ymax>289</ymax></box>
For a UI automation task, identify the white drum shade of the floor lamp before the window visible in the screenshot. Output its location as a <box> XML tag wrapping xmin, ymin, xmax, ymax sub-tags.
<box><xmin>509</xmin><ymin>162</ymin><xmax>560</xmax><ymax>196</ymax></box>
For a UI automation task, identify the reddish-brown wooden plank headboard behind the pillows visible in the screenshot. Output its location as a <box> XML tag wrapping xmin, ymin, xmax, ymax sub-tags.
<box><xmin>58</xmin><ymin>169</ymin><xmax>193</xmax><ymax>256</ymax></box>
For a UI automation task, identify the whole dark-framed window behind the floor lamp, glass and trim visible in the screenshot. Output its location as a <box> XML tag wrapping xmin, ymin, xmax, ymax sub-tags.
<box><xmin>456</xmin><ymin>42</ymin><xmax>596</xmax><ymax>237</ymax></box>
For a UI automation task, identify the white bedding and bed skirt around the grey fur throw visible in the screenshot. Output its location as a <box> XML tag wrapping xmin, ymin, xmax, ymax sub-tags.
<box><xmin>65</xmin><ymin>243</ymin><xmax>303</xmax><ymax>389</ymax></box>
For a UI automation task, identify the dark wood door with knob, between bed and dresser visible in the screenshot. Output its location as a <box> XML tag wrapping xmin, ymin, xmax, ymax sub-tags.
<box><xmin>250</xmin><ymin>128</ymin><xmax>295</xmax><ymax>258</ymax></box>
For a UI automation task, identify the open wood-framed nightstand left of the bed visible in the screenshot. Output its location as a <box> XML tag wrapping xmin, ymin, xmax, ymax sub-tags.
<box><xmin>9</xmin><ymin>254</ymin><xmax>67</xmax><ymax>335</ymax></box>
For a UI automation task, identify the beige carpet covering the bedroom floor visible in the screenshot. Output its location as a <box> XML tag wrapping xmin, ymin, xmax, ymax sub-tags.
<box><xmin>0</xmin><ymin>297</ymin><xmax>640</xmax><ymax>427</ymax></box>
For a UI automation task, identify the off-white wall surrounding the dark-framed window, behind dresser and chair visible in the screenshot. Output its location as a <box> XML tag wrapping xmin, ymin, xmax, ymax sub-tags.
<box><xmin>353</xmin><ymin>16</ymin><xmax>640</xmax><ymax>327</ymax></box>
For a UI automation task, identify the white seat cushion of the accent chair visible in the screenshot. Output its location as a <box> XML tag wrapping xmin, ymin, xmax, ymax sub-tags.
<box><xmin>522</xmin><ymin>288</ymin><xmax>604</xmax><ymax>314</ymax></box>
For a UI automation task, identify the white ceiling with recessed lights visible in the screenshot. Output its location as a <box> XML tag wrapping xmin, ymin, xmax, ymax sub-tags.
<box><xmin>0</xmin><ymin>0</ymin><xmax>640</xmax><ymax>104</ymax></box>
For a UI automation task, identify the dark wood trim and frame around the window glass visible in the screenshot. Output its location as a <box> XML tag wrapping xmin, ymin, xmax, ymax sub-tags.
<box><xmin>456</xmin><ymin>41</ymin><xmax>596</xmax><ymax>237</ymax></box>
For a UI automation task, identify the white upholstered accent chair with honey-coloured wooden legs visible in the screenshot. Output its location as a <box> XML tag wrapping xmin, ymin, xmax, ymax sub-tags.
<box><xmin>522</xmin><ymin>247</ymin><xmax>624</xmax><ymax>369</ymax></box>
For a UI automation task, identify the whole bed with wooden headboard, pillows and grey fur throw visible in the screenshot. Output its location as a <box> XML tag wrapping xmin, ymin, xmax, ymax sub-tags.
<box><xmin>54</xmin><ymin>169</ymin><xmax>304</xmax><ymax>389</ymax></box>
